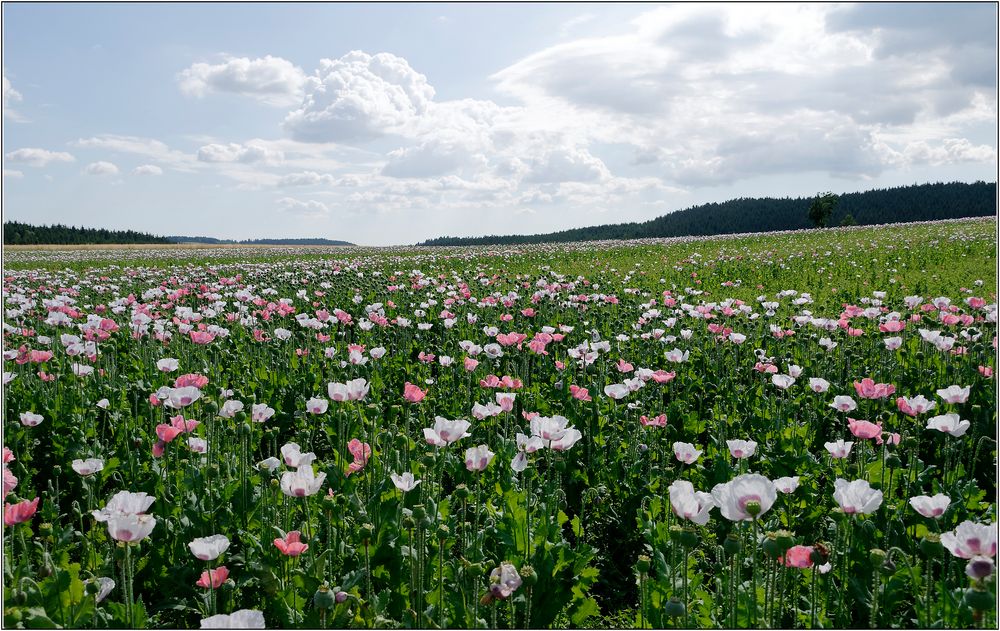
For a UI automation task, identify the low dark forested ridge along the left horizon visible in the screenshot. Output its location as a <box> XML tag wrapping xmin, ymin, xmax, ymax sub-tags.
<box><xmin>3</xmin><ymin>221</ymin><xmax>354</xmax><ymax>245</ymax></box>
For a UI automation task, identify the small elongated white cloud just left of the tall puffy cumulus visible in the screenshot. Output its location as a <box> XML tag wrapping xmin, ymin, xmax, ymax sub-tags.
<box><xmin>177</xmin><ymin>55</ymin><xmax>305</xmax><ymax>106</ymax></box>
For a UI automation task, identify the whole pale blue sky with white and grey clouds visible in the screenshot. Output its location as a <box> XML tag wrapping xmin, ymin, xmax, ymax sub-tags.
<box><xmin>2</xmin><ymin>3</ymin><xmax>997</xmax><ymax>245</ymax></box>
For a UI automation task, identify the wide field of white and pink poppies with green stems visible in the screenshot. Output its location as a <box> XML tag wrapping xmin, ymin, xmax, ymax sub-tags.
<box><xmin>3</xmin><ymin>219</ymin><xmax>997</xmax><ymax>628</ymax></box>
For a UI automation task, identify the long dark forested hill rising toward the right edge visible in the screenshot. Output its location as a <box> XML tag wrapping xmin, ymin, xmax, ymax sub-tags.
<box><xmin>419</xmin><ymin>182</ymin><xmax>997</xmax><ymax>245</ymax></box>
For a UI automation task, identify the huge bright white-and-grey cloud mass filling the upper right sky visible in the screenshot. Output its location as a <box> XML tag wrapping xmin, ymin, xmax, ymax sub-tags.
<box><xmin>493</xmin><ymin>5</ymin><xmax>996</xmax><ymax>185</ymax></box>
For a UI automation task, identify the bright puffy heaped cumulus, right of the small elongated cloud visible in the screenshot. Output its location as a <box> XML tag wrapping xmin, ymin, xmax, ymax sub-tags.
<box><xmin>284</xmin><ymin>50</ymin><xmax>434</xmax><ymax>142</ymax></box>
